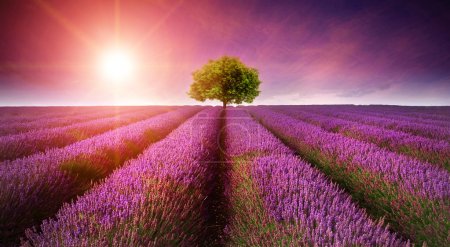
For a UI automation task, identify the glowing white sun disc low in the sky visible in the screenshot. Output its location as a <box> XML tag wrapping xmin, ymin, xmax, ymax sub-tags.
<box><xmin>100</xmin><ymin>48</ymin><xmax>135</xmax><ymax>83</ymax></box>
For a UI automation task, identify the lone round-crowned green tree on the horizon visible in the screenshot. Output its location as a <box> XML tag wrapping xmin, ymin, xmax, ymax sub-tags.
<box><xmin>188</xmin><ymin>56</ymin><xmax>261</xmax><ymax>108</ymax></box>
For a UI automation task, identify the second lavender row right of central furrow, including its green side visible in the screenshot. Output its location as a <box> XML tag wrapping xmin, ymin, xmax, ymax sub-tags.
<box><xmin>251</xmin><ymin>108</ymin><xmax>450</xmax><ymax>246</ymax></box>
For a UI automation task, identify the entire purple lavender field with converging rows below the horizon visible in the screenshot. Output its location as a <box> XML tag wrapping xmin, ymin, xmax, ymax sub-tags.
<box><xmin>0</xmin><ymin>105</ymin><xmax>450</xmax><ymax>246</ymax></box>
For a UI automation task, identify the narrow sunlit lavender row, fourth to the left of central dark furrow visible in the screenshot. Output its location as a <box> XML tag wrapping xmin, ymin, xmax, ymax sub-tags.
<box><xmin>0</xmin><ymin>107</ymin><xmax>160</xmax><ymax>136</ymax></box>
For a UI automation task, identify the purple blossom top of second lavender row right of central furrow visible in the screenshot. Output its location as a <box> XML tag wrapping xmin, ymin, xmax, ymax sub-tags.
<box><xmin>250</xmin><ymin>107</ymin><xmax>450</xmax><ymax>199</ymax></box>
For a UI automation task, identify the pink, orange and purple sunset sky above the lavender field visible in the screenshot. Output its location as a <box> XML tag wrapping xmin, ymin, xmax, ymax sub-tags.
<box><xmin>0</xmin><ymin>0</ymin><xmax>450</xmax><ymax>105</ymax></box>
